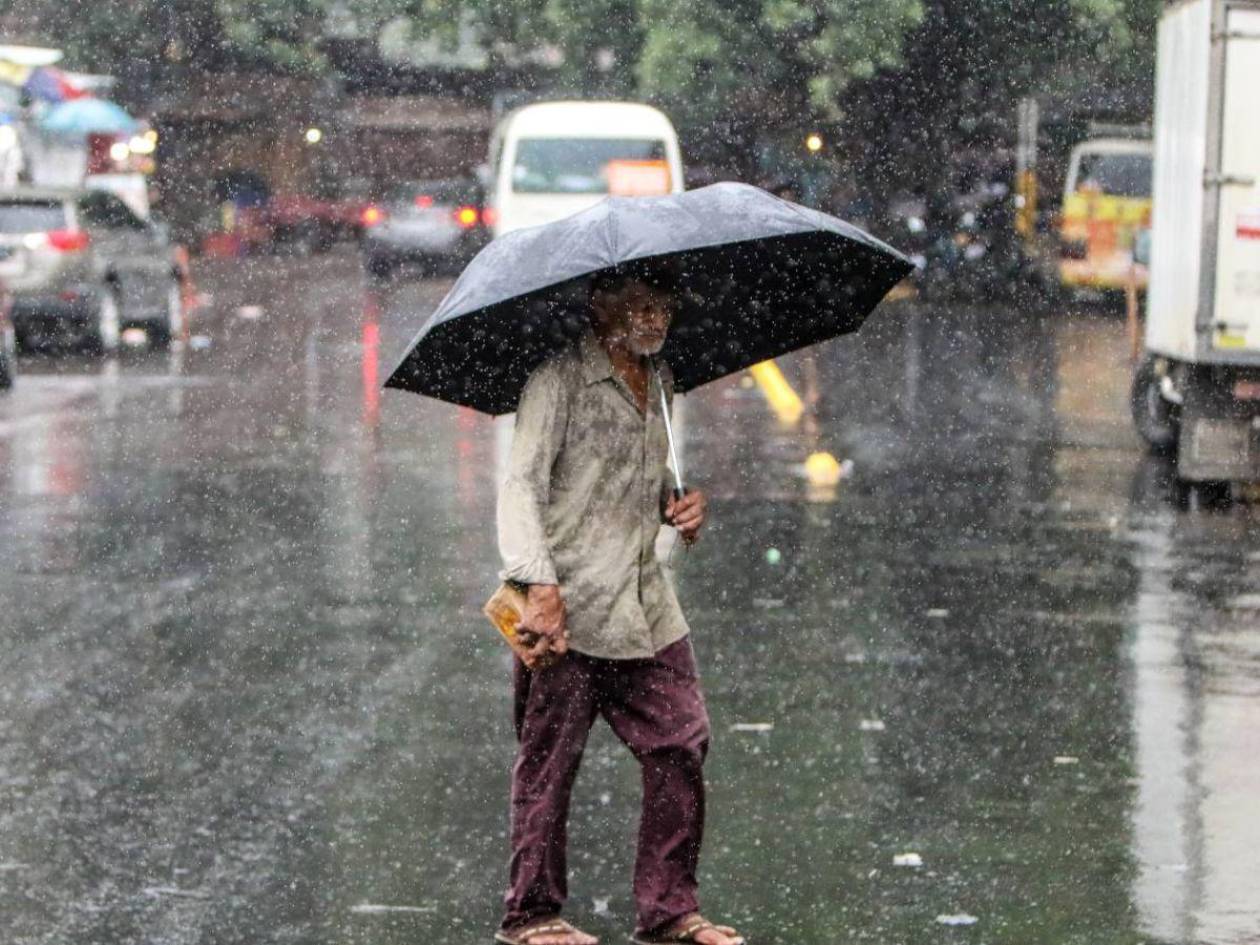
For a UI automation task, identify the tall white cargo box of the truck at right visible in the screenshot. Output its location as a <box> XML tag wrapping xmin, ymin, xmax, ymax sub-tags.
<box><xmin>1147</xmin><ymin>0</ymin><xmax>1260</xmax><ymax>365</ymax></box>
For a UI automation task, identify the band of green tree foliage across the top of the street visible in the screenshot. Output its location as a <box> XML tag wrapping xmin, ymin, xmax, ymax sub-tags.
<box><xmin>0</xmin><ymin>0</ymin><xmax>1160</xmax><ymax>183</ymax></box>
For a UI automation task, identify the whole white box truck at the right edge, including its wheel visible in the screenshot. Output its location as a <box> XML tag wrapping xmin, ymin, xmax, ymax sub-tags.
<box><xmin>1133</xmin><ymin>0</ymin><xmax>1260</xmax><ymax>488</ymax></box>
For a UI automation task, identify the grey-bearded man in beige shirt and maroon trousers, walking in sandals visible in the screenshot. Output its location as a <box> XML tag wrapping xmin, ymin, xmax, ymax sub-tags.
<box><xmin>495</xmin><ymin>266</ymin><xmax>742</xmax><ymax>945</ymax></box>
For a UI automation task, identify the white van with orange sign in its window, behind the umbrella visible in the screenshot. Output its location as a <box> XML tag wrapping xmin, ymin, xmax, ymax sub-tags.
<box><xmin>489</xmin><ymin>102</ymin><xmax>683</xmax><ymax>236</ymax></box>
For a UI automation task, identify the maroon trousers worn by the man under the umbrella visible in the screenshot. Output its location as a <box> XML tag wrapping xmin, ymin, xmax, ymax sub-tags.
<box><xmin>501</xmin><ymin>638</ymin><xmax>709</xmax><ymax>932</ymax></box>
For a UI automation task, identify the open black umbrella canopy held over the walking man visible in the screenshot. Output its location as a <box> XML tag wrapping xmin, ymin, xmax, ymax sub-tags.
<box><xmin>386</xmin><ymin>184</ymin><xmax>914</xmax><ymax>415</ymax></box>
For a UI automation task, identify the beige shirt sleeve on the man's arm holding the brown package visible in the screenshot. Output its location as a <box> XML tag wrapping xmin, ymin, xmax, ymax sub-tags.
<box><xmin>496</xmin><ymin>362</ymin><xmax>568</xmax><ymax>585</ymax></box>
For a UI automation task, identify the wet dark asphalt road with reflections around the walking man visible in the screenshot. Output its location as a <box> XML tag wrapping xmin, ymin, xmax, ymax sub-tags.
<box><xmin>0</xmin><ymin>252</ymin><xmax>1260</xmax><ymax>945</ymax></box>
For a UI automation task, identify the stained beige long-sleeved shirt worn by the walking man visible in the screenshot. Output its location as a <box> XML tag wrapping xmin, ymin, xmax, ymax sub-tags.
<box><xmin>498</xmin><ymin>331</ymin><xmax>688</xmax><ymax>659</ymax></box>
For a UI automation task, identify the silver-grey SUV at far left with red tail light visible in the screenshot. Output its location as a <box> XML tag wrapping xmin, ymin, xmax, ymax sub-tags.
<box><xmin>0</xmin><ymin>188</ymin><xmax>184</xmax><ymax>352</ymax></box>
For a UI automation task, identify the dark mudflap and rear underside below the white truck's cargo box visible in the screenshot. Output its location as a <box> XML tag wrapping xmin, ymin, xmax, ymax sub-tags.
<box><xmin>1177</xmin><ymin>367</ymin><xmax>1260</xmax><ymax>483</ymax></box>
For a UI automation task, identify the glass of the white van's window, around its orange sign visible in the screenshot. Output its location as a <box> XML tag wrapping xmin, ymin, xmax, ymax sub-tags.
<box><xmin>512</xmin><ymin>137</ymin><xmax>668</xmax><ymax>194</ymax></box>
